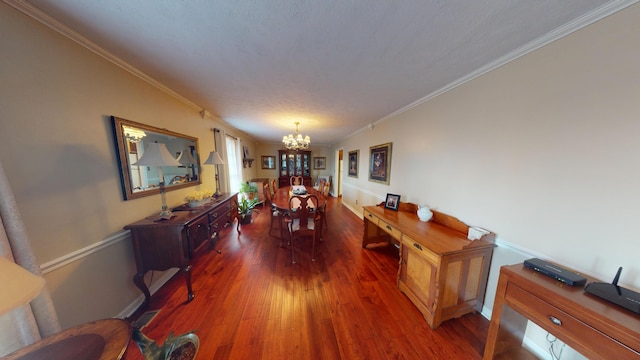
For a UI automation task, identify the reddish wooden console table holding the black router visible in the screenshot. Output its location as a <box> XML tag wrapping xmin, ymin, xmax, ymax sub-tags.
<box><xmin>484</xmin><ymin>264</ymin><xmax>640</xmax><ymax>360</ymax></box>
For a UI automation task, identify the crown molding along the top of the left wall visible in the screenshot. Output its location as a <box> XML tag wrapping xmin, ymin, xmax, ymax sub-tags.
<box><xmin>3</xmin><ymin>0</ymin><xmax>202</xmax><ymax>111</ymax></box>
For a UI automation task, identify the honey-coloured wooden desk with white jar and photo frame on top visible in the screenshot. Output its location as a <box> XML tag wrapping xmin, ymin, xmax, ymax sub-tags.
<box><xmin>362</xmin><ymin>203</ymin><xmax>495</xmax><ymax>329</ymax></box>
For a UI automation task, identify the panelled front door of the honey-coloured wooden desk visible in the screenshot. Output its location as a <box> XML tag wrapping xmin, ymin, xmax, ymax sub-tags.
<box><xmin>398</xmin><ymin>241</ymin><xmax>438</xmax><ymax>314</ymax></box>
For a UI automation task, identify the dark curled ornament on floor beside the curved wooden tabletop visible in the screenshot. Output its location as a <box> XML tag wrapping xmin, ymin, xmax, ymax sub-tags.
<box><xmin>133</xmin><ymin>328</ymin><xmax>200</xmax><ymax>360</ymax></box>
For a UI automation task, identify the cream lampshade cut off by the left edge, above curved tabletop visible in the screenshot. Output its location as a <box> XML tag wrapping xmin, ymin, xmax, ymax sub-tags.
<box><xmin>0</xmin><ymin>256</ymin><xmax>44</xmax><ymax>315</ymax></box>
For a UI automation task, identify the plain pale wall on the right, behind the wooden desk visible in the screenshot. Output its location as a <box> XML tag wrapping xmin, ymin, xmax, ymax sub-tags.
<box><xmin>335</xmin><ymin>4</ymin><xmax>640</xmax><ymax>292</ymax></box>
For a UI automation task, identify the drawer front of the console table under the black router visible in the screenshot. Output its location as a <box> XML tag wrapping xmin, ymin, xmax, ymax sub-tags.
<box><xmin>505</xmin><ymin>284</ymin><xmax>638</xmax><ymax>359</ymax></box>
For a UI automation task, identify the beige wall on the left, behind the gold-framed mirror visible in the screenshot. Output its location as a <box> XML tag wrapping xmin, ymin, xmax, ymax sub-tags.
<box><xmin>0</xmin><ymin>3</ymin><xmax>255</xmax><ymax>327</ymax></box>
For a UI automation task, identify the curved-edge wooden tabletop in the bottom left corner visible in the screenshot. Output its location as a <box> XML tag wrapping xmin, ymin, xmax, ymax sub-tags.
<box><xmin>2</xmin><ymin>319</ymin><xmax>131</xmax><ymax>360</ymax></box>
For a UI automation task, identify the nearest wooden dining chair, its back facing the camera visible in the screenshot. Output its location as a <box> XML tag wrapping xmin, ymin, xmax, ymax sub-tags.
<box><xmin>284</xmin><ymin>194</ymin><xmax>322</xmax><ymax>264</ymax></box>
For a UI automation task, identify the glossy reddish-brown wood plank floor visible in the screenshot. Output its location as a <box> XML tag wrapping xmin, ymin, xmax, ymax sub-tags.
<box><xmin>125</xmin><ymin>198</ymin><xmax>489</xmax><ymax>360</ymax></box>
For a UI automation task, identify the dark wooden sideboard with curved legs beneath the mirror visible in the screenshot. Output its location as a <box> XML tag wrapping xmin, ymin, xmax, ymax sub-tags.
<box><xmin>124</xmin><ymin>194</ymin><xmax>238</xmax><ymax>306</ymax></box>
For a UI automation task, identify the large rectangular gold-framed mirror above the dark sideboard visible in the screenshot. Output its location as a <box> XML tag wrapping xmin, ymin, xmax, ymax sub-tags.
<box><xmin>111</xmin><ymin>116</ymin><xmax>202</xmax><ymax>200</ymax></box>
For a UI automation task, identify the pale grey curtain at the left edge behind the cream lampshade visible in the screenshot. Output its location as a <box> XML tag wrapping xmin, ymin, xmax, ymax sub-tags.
<box><xmin>0</xmin><ymin>163</ymin><xmax>60</xmax><ymax>356</ymax></box>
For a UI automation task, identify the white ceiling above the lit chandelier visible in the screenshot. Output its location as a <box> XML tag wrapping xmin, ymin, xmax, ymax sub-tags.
<box><xmin>13</xmin><ymin>0</ymin><xmax>628</xmax><ymax>145</ymax></box>
